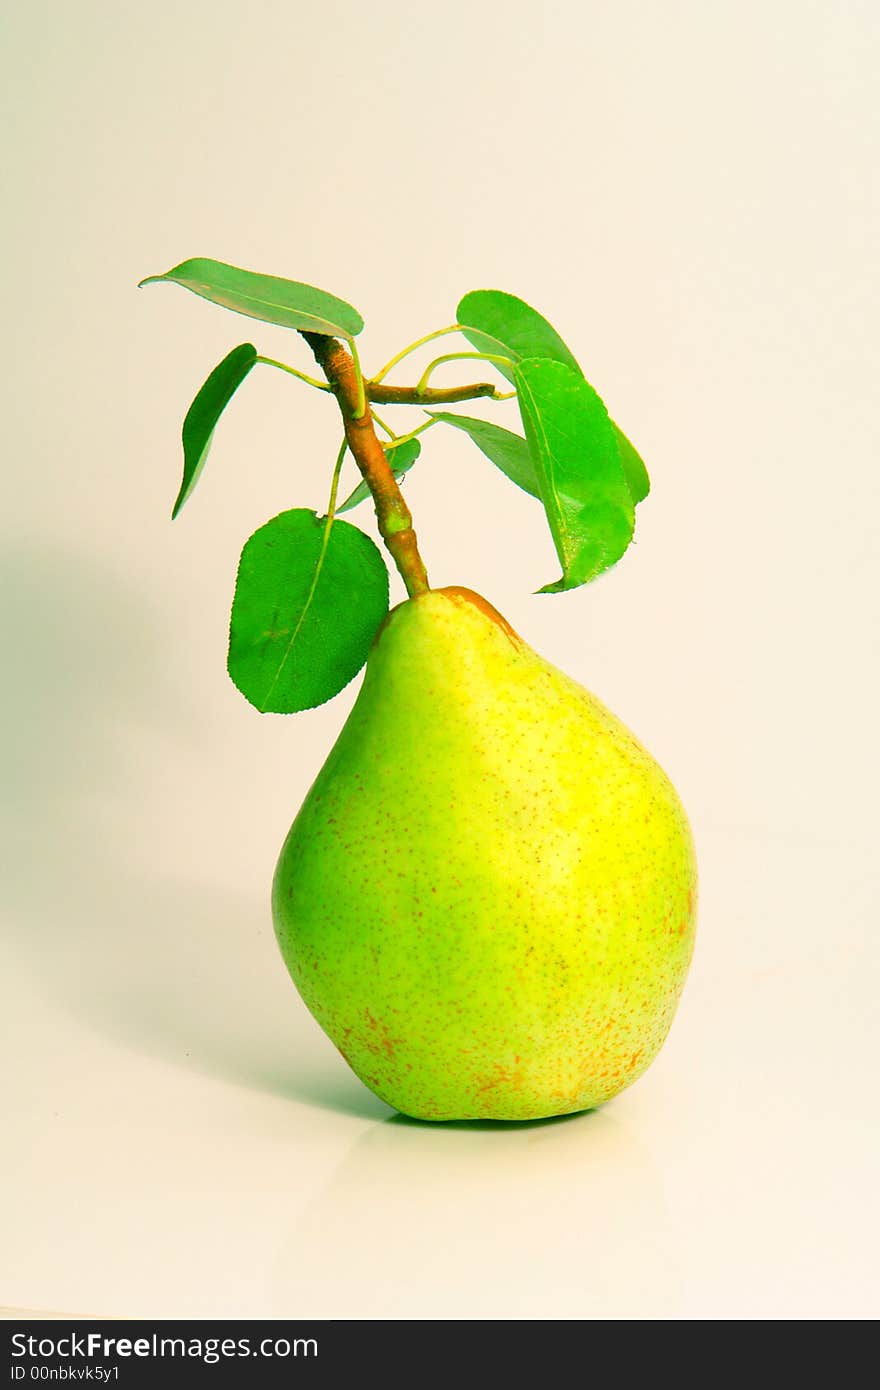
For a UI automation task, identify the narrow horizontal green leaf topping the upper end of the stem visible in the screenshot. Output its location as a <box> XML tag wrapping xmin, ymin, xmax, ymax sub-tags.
<box><xmin>140</xmin><ymin>257</ymin><xmax>364</xmax><ymax>338</ymax></box>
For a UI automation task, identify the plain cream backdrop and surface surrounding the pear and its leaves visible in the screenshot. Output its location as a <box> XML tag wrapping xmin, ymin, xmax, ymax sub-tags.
<box><xmin>0</xmin><ymin>0</ymin><xmax>880</xmax><ymax>1319</ymax></box>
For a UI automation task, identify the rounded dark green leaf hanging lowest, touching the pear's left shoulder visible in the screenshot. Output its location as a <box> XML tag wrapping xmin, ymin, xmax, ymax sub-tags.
<box><xmin>228</xmin><ymin>507</ymin><xmax>388</xmax><ymax>714</ymax></box>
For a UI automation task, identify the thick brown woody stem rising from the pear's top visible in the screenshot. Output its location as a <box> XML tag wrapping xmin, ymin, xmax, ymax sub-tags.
<box><xmin>303</xmin><ymin>332</ymin><xmax>431</xmax><ymax>598</ymax></box>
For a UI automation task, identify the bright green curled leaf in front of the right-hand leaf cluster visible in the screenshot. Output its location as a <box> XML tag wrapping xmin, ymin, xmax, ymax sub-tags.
<box><xmin>514</xmin><ymin>359</ymin><xmax>634</xmax><ymax>594</ymax></box>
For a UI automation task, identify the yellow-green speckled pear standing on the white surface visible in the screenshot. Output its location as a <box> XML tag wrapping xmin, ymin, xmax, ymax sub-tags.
<box><xmin>272</xmin><ymin>588</ymin><xmax>696</xmax><ymax>1120</ymax></box>
